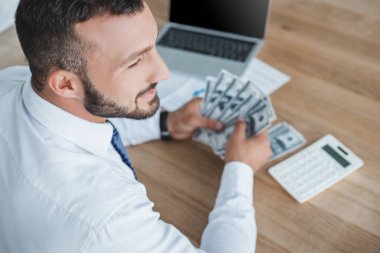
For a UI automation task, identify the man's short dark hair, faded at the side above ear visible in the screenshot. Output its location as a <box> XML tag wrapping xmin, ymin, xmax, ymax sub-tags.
<box><xmin>16</xmin><ymin>0</ymin><xmax>144</xmax><ymax>90</ymax></box>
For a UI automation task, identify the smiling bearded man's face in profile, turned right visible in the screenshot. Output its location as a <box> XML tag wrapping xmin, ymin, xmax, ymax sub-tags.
<box><xmin>76</xmin><ymin>5</ymin><xmax>169</xmax><ymax>119</ymax></box>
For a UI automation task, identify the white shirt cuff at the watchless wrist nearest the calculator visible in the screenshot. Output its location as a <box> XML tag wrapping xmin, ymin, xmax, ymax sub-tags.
<box><xmin>217</xmin><ymin>161</ymin><xmax>254</xmax><ymax>205</ymax></box>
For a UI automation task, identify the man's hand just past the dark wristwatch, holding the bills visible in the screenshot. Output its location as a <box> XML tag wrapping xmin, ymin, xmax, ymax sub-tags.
<box><xmin>167</xmin><ymin>98</ymin><xmax>223</xmax><ymax>140</ymax></box>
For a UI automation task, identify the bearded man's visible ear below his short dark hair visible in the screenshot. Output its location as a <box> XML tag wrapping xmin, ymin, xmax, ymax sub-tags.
<box><xmin>47</xmin><ymin>69</ymin><xmax>83</xmax><ymax>99</ymax></box>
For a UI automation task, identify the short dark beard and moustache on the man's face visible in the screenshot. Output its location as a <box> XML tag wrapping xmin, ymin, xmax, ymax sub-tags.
<box><xmin>82</xmin><ymin>72</ymin><xmax>160</xmax><ymax>120</ymax></box>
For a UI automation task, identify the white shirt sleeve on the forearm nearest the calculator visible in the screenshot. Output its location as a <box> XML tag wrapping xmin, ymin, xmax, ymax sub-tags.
<box><xmin>201</xmin><ymin>162</ymin><xmax>257</xmax><ymax>253</ymax></box>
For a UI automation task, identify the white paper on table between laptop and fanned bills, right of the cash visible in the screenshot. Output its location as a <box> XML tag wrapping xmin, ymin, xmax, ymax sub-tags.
<box><xmin>241</xmin><ymin>58</ymin><xmax>290</xmax><ymax>95</ymax></box>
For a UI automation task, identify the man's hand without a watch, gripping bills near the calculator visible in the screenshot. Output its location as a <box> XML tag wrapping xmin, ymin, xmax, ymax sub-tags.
<box><xmin>225</xmin><ymin>120</ymin><xmax>272</xmax><ymax>172</ymax></box>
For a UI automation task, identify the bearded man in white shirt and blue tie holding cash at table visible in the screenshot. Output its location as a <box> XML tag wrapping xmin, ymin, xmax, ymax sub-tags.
<box><xmin>0</xmin><ymin>0</ymin><xmax>270</xmax><ymax>253</ymax></box>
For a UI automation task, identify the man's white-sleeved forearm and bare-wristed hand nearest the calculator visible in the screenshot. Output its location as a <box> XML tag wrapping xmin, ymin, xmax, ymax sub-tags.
<box><xmin>201</xmin><ymin>120</ymin><xmax>271</xmax><ymax>253</ymax></box>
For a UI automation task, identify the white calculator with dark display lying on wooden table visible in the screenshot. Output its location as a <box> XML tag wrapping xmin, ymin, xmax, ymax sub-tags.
<box><xmin>269</xmin><ymin>134</ymin><xmax>363</xmax><ymax>203</ymax></box>
